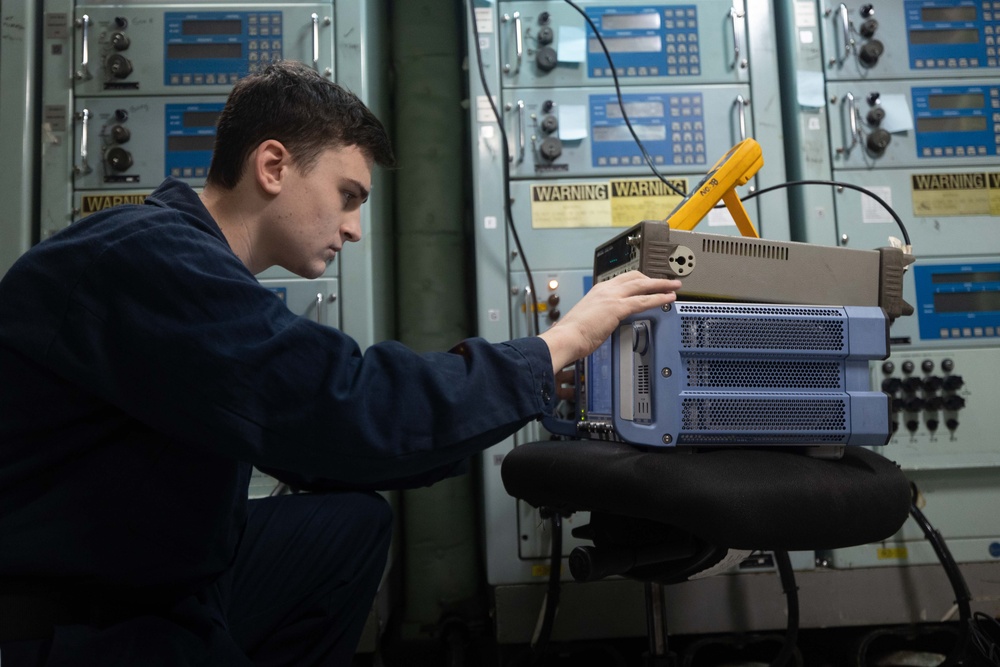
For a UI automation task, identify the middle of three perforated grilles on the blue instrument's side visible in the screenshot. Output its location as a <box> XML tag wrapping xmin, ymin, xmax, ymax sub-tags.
<box><xmin>686</xmin><ymin>359</ymin><xmax>842</xmax><ymax>389</ymax></box>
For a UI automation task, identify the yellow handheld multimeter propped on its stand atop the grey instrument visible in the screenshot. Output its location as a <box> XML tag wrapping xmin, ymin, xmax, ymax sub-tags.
<box><xmin>665</xmin><ymin>139</ymin><xmax>764</xmax><ymax>238</ymax></box>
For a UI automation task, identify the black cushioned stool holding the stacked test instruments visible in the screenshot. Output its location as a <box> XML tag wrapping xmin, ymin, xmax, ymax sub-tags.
<box><xmin>501</xmin><ymin>440</ymin><xmax>910</xmax><ymax>664</ymax></box>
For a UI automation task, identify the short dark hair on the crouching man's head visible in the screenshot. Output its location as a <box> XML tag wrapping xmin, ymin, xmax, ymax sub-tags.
<box><xmin>207</xmin><ymin>60</ymin><xmax>395</xmax><ymax>190</ymax></box>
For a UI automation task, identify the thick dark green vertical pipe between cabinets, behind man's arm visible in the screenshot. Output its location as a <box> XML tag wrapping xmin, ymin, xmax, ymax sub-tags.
<box><xmin>392</xmin><ymin>0</ymin><xmax>479</xmax><ymax>633</ymax></box>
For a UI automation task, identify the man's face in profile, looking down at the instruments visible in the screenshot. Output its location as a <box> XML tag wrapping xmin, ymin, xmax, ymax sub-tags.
<box><xmin>267</xmin><ymin>146</ymin><xmax>372</xmax><ymax>278</ymax></box>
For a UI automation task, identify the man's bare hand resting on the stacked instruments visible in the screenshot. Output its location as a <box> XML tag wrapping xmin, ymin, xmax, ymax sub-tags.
<box><xmin>539</xmin><ymin>271</ymin><xmax>681</xmax><ymax>373</ymax></box>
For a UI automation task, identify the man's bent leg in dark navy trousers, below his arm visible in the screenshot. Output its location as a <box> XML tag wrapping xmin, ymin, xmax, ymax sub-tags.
<box><xmin>220</xmin><ymin>493</ymin><xmax>392</xmax><ymax>667</ymax></box>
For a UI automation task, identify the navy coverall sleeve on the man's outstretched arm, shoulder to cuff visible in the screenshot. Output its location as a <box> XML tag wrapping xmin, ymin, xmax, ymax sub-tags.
<box><xmin>48</xmin><ymin>224</ymin><xmax>555</xmax><ymax>485</ymax></box>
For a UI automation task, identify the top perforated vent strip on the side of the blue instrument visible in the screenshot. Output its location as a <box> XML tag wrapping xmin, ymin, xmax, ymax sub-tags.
<box><xmin>681</xmin><ymin>317</ymin><xmax>845</xmax><ymax>350</ymax></box>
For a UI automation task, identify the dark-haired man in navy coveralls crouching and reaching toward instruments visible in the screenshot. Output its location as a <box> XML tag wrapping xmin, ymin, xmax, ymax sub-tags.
<box><xmin>0</xmin><ymin>63</ymin><xmax>680</xmax><ymax>667</ymax></box>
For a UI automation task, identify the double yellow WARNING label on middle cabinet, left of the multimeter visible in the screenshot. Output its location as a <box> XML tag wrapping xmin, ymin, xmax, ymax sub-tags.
<box><xmin>531</xmin><ymin>178</ymin><xmax>688</xmax><ymax>229</ymax></box>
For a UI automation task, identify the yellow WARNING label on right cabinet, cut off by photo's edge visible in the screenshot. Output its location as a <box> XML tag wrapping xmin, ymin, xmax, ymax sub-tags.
<box><xmin>910</xmin><ymin>172</ymin><xmax>1000</xmax><ymax>217</ymax></box>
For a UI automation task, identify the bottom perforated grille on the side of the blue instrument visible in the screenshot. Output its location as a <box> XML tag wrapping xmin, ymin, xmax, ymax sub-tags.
<box><xmin>681</xmin><ymin>397</ymin><xmax>847</xmax><ymax>433</ymax></box>
